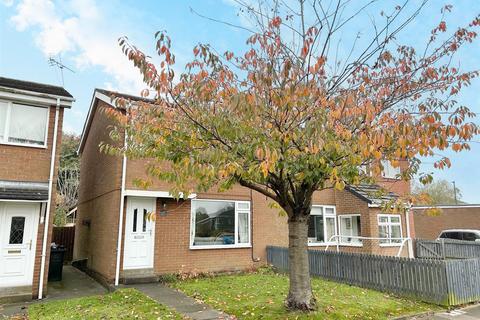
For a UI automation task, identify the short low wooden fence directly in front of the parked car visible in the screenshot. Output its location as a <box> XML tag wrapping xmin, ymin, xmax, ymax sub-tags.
<box><xmin>415</xmin><ymin>239</ymin><xmax>480</xmax><ymax>259</ymax></box>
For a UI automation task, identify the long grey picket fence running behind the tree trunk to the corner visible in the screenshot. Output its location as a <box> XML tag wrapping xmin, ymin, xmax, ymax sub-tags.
<box><xmin>267</xmin><ymin>247</ymin><xmax>448</xmax><ymax>305</ymax></box>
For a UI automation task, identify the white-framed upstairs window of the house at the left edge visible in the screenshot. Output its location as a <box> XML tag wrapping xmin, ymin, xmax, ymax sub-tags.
<box><xmin>0</xmin><ymin>101</ymin><xmax>48</xmax><ymax>147</ymax></box>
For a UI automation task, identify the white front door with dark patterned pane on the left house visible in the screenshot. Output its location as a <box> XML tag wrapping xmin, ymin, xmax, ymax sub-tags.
<box><xmin>0</xmin><ymin>202</ymin><xmax>40</xmax><ymax>287</ymax></box>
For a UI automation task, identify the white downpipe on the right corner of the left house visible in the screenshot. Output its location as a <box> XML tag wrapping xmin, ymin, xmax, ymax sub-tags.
<box><xmin>38</xmin><ymin>98</ymin><xmax>60</xmax><ymax>299</ymax></box>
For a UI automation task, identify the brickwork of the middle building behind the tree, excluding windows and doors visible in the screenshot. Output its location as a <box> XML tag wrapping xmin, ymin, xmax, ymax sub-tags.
<box><xmin>79</xmin><ymin>99</ymin><xmax>412</xmax><ymax>282</ymax></box>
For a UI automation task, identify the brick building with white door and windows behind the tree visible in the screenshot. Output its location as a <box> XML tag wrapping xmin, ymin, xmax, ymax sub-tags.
<box><xmin>74</xmin><ymin>89</ymin><xmax>412</xmax><ymax>284</ymax></box>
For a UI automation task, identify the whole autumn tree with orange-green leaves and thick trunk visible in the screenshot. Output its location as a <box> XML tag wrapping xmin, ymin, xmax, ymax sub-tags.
<box><xmin>102</xmin><ymin>0</ymin><xmax>480</xmax><ymax>310</ymax></box>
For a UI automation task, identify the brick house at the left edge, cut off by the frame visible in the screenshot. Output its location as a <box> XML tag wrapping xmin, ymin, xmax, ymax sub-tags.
<box><xmin>0</xmin><ymin>77</ymin><xmax>74</xmax><ymax>300</ymax></box>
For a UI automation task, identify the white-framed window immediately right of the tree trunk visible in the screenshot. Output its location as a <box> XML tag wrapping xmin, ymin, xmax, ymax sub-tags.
<box><xmin>308</xmin><ymin>206</ymin><xmax>337</xmax><ymax>245</ymax></box>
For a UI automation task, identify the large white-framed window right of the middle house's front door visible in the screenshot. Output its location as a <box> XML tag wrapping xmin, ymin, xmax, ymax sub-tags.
<box><xmin>190</xmin><ymin>200</ymin><xmax>250</xmax><ymax>249</ymax></box>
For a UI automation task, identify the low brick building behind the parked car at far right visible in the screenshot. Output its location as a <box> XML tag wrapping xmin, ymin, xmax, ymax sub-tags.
<box><xmin>412</xmin><ymin>204</ymin><xmax>480</xmax><ymax>240</ymax></box>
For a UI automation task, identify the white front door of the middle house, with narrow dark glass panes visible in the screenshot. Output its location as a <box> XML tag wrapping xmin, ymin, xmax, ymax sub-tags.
<box><xmin>123</xmin><ymin>197</ymin><xmax>155</xmax><ymax>269</ymax></box>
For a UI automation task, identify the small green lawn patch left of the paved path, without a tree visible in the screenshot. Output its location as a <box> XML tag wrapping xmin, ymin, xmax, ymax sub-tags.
<box><xmin>28</xmin><ymin>289</ymin><xmax>183</xmax><ymax>320</ymax></box>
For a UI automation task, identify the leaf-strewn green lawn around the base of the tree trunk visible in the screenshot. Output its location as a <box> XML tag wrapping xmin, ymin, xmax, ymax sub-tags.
<box><xmin>171</xmin><ymin>271</ymin><xmax>439</xmax><ymax>319</ymax></box>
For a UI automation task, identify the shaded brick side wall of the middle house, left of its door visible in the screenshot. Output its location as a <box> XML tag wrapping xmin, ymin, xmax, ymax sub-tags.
<box><xmin>73</xmin><ymin>101</ymin><xmax>122</xmax><ymax>280</ymax></box>
